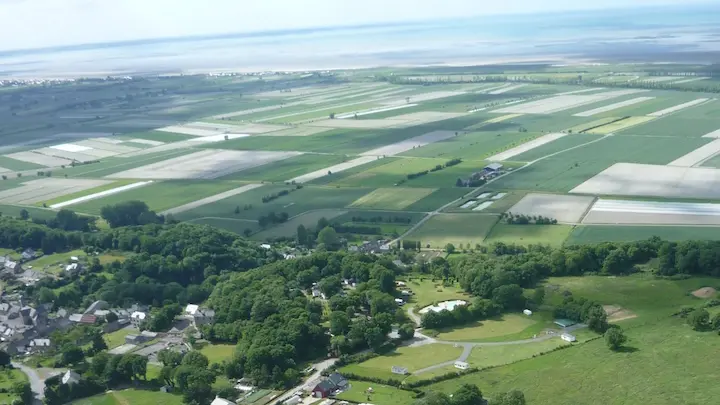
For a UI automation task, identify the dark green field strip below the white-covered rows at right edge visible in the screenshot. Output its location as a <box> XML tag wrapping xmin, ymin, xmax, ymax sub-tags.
<box><xmin>565</xmin><ymin>225</ymin><xmax>720</xmax><ymax>245</ymax></box>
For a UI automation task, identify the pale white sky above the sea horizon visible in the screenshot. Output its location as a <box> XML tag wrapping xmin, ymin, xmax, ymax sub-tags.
<box><xmin>0</xmin><ymin>0</ymin><xmax>713</xmax><ymax>50</ymax></box>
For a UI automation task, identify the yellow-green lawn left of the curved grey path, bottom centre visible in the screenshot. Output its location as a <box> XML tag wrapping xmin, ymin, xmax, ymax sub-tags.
<box><xmin>339</xmin><ymin>343</ymin><xmax>463</xmax><ymax>379</ymax></box>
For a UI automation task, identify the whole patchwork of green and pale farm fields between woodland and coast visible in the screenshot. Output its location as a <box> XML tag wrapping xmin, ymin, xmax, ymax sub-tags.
<box><xmin>0</xmin><ymin>68</ymin><xmax>720</xmax><ymax>249</ymax></box>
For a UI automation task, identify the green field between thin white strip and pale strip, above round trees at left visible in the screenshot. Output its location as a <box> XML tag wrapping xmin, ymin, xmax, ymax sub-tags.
<box><xmin>73</xmin><ymin>180</ymin><xmax>240</xmax><ymax>215</ymax></box>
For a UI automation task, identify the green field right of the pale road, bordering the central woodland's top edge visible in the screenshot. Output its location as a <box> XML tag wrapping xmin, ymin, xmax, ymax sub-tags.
<box><xmin>406</xmin><ymin>214</ymin><xmax>498</xmax><ymax>249</ymax></box>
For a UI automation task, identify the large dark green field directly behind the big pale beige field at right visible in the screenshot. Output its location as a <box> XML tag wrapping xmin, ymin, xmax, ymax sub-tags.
<box><xmin>492</xmin><ymin>136</ymin><xmax>708</xmax><ymax>192</ymax></box>
